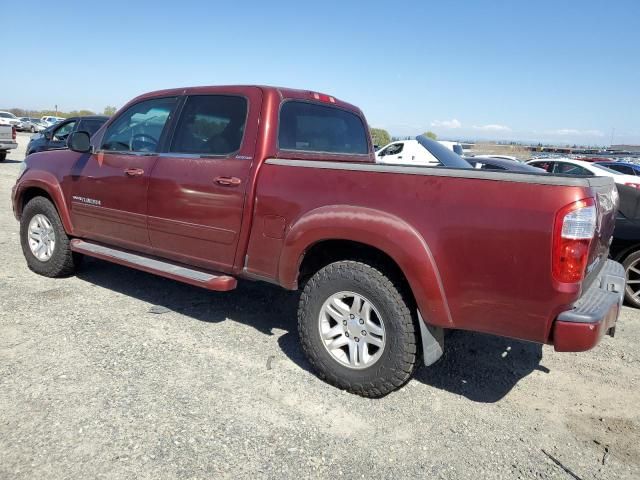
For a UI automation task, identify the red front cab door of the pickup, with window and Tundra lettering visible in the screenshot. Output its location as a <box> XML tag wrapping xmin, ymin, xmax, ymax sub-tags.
<box><xmin>71</xmin><ymin>97</ymin><xmax>177</xmax><ymax>252</ymax></box>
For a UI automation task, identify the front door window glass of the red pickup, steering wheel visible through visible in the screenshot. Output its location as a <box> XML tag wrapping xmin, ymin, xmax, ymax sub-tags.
<box><xmin>102</xmin><ymin>97</ymin><xmax>176</xmax><ymax>152</ymax></box>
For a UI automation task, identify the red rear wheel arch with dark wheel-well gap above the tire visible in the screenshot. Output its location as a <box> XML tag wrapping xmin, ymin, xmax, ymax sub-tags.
<box><xmin>278</xmin><ymin>205</ymin><xmax>454</xmax><ymax>328</ymax></box>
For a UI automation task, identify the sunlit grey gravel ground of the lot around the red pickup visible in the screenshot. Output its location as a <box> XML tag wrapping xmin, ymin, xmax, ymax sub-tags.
<box><xmin>0</xmin><ymin>135</ymin><xmax>640</xmax><ymax>479</ymax></box>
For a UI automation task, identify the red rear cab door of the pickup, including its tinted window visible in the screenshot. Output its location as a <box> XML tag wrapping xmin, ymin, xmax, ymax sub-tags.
<box><xmin>149</xmin><ymin>87</ymin><xmax>262</xmax><ymax>272</ymax></box>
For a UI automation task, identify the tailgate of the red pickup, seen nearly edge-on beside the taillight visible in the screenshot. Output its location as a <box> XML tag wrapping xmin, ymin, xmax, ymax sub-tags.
<box><xmin>583</xmin><ymin>179</ymin><xmax>618</xmax><ymax>289</ymax></box>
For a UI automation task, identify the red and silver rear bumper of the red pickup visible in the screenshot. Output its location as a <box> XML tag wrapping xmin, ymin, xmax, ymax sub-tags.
<box><xmin>553</xmin><ymin>260</ymin><xmax>625</xmax><ymax>352</ymax></box>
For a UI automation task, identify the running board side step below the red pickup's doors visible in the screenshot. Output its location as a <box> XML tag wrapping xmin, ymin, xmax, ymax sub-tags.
<box><xmin>71</xmin><ymin>238</ymin><xmax>238</xmax><ymax>292</ymax></box>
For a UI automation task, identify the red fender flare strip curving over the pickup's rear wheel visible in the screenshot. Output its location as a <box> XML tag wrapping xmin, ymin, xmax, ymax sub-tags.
<box><xmin>278</xmin><ymin>205</ymin><xmax>454</xmax><ymax>328</ymax></box>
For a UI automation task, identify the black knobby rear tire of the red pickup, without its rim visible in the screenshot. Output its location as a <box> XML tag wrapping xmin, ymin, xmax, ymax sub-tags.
<box><xmin>298</xmin><ymin>260</ymin><xmax>418</xmax><ymax>398</ymax></box>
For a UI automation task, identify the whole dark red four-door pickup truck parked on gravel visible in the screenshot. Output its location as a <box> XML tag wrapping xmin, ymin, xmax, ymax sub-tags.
<box><xmin>13</xmin><ymin>86</ymin><xmax>625</xmax><ymax>397</ymax></box>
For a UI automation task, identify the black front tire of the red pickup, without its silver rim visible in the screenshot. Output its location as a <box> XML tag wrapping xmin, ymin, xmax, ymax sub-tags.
<box><xmin>20</xmin><ymin>197</ymin><xmax>79</xmax><ymax>277</ymax></box>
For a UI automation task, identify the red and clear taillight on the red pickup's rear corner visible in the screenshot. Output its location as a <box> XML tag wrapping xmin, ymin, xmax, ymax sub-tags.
<box><xmin>552</xmin><ymin>198</ymin><xmax>598</xmax><ymax>283</ymax></box>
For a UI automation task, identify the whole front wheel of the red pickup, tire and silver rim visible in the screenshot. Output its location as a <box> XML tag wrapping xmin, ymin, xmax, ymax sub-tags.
<box><xmin>20</xmin><ymin>197</ymin><xmax>78</xmax><ymax>277</ymax></box>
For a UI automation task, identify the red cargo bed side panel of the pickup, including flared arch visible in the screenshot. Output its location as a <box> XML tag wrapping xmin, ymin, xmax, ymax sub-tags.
<box><xmin>247</xmin><ymin>163</ymin><xmax>589</xmax><ymax>342</ymax></box>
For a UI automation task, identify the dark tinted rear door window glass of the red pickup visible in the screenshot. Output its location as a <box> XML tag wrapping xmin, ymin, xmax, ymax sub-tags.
<box><xmin>170</xmin><ymin>95</ymin><xmax>247</xmax><ymax>155</ymax></box>
